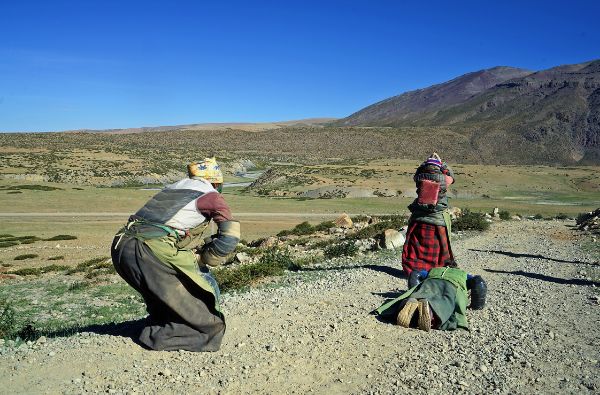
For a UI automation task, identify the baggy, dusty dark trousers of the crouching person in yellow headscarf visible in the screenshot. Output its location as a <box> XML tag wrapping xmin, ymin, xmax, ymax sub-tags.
<box><xmin>111</xmin><ymin>236</ymin><xmax>225</xmax><ymax>351</ymax></box>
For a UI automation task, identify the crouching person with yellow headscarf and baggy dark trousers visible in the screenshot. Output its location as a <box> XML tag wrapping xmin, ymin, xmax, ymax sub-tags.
<box><xmin>111</xmin><ymin>158</ymin><xmax>240</xmax><ymax>351</ymax></box>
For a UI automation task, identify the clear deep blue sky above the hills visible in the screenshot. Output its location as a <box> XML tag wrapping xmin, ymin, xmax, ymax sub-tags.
<box><xmin>0</xmin><ymin>0</ymin><xmax>600</xmax><ymax>131</ymax></box>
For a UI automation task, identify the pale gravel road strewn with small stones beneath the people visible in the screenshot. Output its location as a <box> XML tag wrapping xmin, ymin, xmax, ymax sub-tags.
<box><xmin>0</xmin><ymin>221</ymin><xmax>600</xmax><ymax>394</ymax></box>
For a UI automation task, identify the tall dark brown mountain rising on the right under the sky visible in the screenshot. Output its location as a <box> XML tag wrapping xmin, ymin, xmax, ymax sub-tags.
<box><xmin>334</xmin><ymin>60</ymin><xmax>600</xmax><ymax>164</ymax></box>
